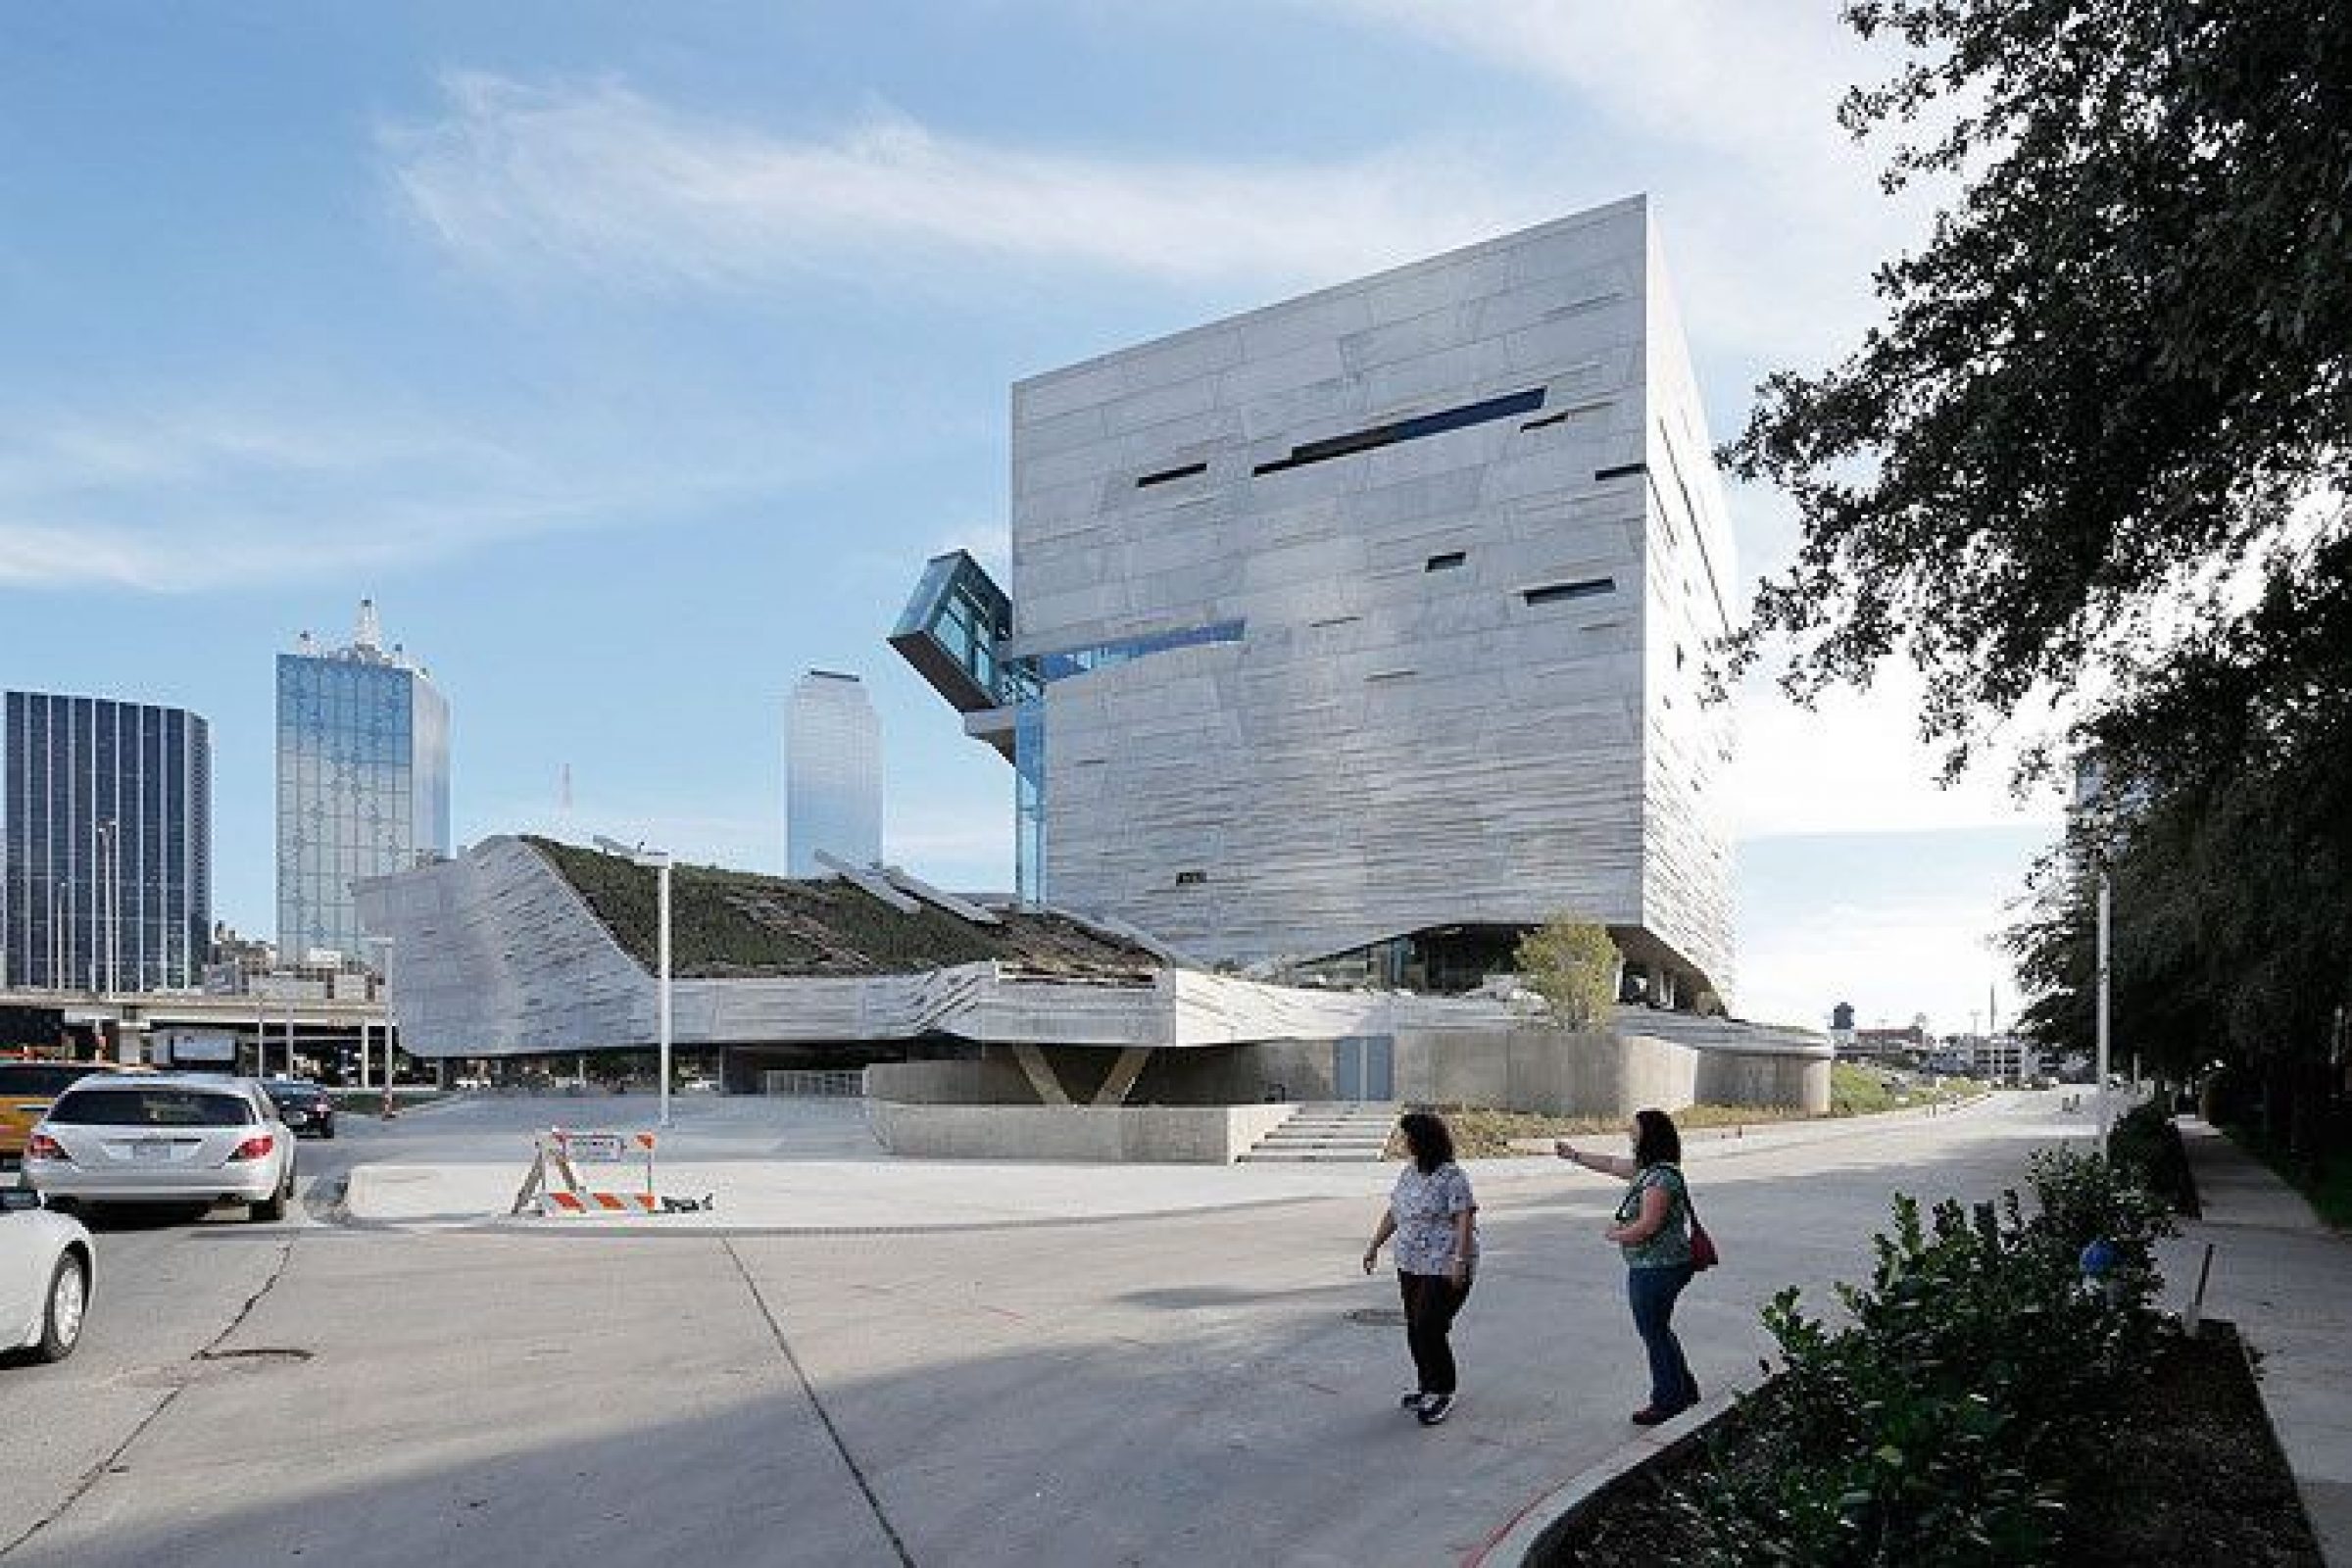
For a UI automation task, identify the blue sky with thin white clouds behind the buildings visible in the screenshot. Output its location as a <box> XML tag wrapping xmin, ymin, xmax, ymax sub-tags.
<box><xmin>0</xmin><ymin>0</ymin><xmax>2048</xmax><ymax>1027</ymax></box>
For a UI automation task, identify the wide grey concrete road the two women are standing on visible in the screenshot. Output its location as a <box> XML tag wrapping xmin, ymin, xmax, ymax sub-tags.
<box><xmin>0</xmin><ymin>1096</ymin><xmax>2080</xmax><ymax>1568</ymax></box>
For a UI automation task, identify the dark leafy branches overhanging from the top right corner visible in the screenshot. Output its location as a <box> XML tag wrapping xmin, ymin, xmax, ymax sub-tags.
<box><xmin>1724</xmin><ymin>0</ymin><xmax>2352</xmax><ymax>753</ymax></box>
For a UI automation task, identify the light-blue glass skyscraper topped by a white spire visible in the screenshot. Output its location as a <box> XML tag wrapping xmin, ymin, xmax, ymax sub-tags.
<box><xmin>277</xmin><ymin>600</ymin><xmax>449</xmax><ymax>961</ymax></box>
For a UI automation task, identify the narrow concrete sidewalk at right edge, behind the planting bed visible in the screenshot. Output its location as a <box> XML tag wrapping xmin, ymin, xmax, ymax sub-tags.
<box><xmin>2164</xmin><ymin>1116</ymin><xmax>2352</xmax><ymax>1568</ymax></box>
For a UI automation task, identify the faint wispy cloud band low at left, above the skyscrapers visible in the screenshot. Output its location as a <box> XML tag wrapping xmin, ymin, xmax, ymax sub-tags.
<box><xmin>0</xmin><ymin>388</ymin><xmax>840</xmax><ymax>592</ymax></box>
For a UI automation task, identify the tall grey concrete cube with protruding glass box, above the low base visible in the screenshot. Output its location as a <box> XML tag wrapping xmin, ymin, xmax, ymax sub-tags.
<box><xmin>892</xmin><ymin>197</ymin><xmax>1734</xmax><ymax>1006</ymax></box>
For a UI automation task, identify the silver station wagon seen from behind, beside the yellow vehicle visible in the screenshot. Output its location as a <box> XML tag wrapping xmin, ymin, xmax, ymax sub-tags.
<box><xmin>24</xmin><ymin>1072</ymin><xmax>294</xmax><ymax>1220</ymax></box>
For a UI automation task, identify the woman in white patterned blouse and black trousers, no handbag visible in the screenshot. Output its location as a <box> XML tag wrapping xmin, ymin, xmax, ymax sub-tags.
<box><xmin>1364</xmin><ymin>1109</ymin><xmax>1477</xmax><ymax>1427</ymax></box>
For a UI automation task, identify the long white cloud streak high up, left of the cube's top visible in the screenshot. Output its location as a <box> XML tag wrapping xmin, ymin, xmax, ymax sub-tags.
<box><xmin>381</xmin><ymin>73</ymin><xmax>1547</xmax><ymax>289</ymax></box>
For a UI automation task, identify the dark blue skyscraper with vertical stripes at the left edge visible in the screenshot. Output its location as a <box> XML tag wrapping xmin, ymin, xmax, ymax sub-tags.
<box><xmin>0</xmin><ymin>691</ymin><xmax>212</xmax><ymax>992</ymax></box>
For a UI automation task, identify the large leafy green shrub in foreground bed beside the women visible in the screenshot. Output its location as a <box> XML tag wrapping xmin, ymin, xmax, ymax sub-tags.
<box><xmin>1677</xmin><ymin>1152</ymin><xmax>2171</xmax><ymax>1568</ymax></box>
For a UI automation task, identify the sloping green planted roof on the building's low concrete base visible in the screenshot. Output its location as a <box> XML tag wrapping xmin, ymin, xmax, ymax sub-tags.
<box><xmin>524</xmin><ymin>837</ymin><xmax>1159</xmax><ymax>980</ymax></box>
